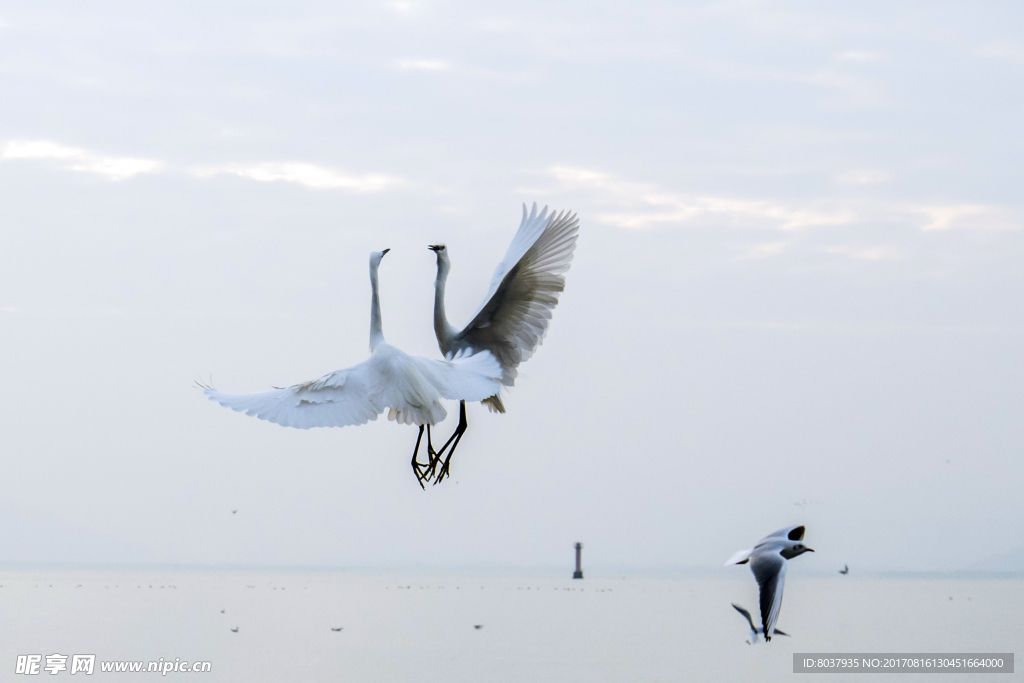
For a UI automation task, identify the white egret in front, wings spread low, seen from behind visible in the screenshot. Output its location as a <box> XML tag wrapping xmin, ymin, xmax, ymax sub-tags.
<box><xmin>203</xmin><ymin>249</ymin><xmax>502</xmax><ymax>486</ymax></box>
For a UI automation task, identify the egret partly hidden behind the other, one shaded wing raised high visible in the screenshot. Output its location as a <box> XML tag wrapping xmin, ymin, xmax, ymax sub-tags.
<box><xmin>428</xmin><ymin>202</ymin><xmax>580</xmax><ymax>483</ymax></box>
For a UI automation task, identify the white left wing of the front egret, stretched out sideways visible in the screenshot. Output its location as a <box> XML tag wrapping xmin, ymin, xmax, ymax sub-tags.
<box><xmin>203</xmin><ymin>360</ymin><xmax>385</xmax><ymax>429</ymax></box>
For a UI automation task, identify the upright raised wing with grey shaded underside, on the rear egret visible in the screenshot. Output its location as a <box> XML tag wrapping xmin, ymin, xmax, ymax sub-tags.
<box><xmin>457</xmin><ymin>204</ymin><xmax>580</xmax><ymax>386</ymax></box>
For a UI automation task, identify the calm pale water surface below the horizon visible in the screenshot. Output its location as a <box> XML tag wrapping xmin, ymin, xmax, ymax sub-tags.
<box><xmin>0</xmin><ymin>569</ymin><xmax>1024</xmax><ymax>683</ymax></box>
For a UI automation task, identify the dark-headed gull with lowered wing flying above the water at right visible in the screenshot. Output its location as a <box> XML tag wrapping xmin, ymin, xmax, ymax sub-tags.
<box><xmin>725</xmin><ymin>525</ymin><xmax>814</xmax><ymax>642</ymax></box>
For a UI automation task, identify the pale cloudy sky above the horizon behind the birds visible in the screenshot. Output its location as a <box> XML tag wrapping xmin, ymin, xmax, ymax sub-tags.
<box><xmin>0</xmin><ymin>0</ymin><xmax>1024</xmax><ymax>574</ymax></box>
